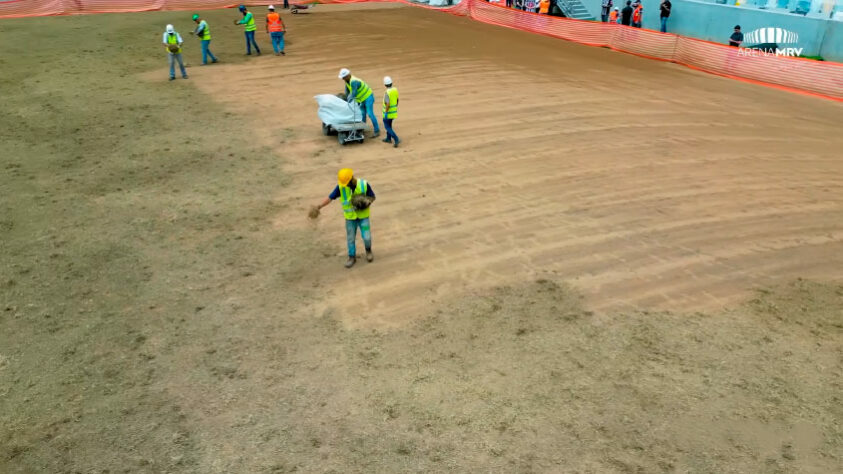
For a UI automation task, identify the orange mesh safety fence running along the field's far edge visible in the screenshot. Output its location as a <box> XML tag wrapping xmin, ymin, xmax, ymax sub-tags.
<box><xmin>0</xmin><ymin>0</ymin><xmax>843</xmax><ymax>101</ymax></box>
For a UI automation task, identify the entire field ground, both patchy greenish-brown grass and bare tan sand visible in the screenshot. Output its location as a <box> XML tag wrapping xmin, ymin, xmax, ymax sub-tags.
<box><xmin>0</xmin><ymin>5</ymin><xmax>843</xmax><ymax>473</ymax></box>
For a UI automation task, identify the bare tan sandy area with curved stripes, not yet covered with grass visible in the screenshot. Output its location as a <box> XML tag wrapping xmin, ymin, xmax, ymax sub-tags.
<box><xmin>192</xmin><ymin>6</ymin><xmax>843</xmax><ymax>326</ymax></box>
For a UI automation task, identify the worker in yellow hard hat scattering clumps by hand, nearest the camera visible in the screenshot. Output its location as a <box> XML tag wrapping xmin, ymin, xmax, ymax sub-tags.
<box><xmin>311</xmin><ymin>168</ymin><xmax>375</xmax><ymax>268</ymax></box>
